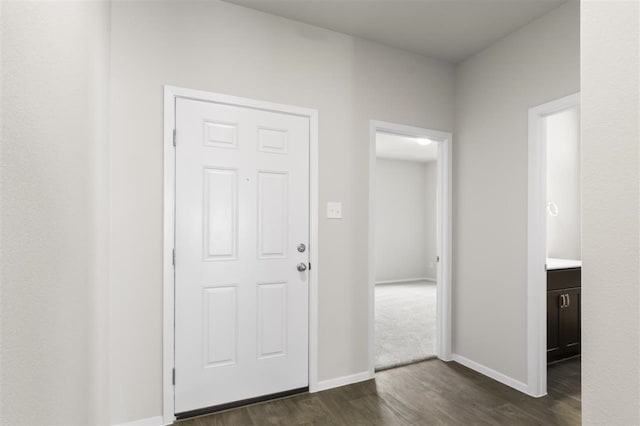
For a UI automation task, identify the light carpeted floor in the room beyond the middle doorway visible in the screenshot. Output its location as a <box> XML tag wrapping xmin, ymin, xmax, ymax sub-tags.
<box><xmin>375</xmin><ymin>281</ymin><xmax>436</xmax><ymax>370</ymax></box>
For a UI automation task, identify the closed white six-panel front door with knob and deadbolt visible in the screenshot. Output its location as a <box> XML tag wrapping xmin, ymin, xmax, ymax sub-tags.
<box><xmin>175</xmin><ymin>98</ymin><xmax>309</xmax><ymax>413</ymax></box>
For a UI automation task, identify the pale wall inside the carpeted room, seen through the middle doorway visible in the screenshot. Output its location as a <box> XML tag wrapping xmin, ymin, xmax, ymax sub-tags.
<box><xmin>375</xmin><ymin>158</ymin><xmax>437</xmax><ymax>282</ymax></box>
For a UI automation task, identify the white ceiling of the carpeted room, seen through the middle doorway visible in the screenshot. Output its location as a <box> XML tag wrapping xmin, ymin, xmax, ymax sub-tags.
<box><xmin>376</xmin><ymin>133</ymin><xmax>438</xmax><ymax>163</ymax></box>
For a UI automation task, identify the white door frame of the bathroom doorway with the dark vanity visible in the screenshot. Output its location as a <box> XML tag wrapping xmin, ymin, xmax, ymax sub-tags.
<box><xmin>527</xmin><ymin>93</ymin><xmax>580</xmax><ymax>397</ymax></box>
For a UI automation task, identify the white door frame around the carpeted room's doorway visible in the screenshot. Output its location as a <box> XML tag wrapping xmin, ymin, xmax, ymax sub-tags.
<box><xmin>369</xmin><ymin>120</ymin><xmax>452</xmax><ymax>377</ymax></box>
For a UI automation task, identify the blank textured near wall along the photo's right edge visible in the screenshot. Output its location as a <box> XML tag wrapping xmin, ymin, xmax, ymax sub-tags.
<box><xmin>581</xmin><ymin>0</ymin><xmax>640</xmax><ymax>425</ymax></box>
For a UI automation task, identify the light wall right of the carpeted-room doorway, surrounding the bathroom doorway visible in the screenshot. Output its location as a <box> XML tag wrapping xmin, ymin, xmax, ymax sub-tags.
<box><xmin>453</xmin><ymin>2</ymin><xmax>580</xmax><ymax>382</ymax></box>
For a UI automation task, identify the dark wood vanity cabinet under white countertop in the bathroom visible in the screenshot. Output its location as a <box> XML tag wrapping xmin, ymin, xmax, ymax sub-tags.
<box><xmin>547</xmin><ymin>268</ymin><xmax>581</xmax><ymax>362</ymax></box>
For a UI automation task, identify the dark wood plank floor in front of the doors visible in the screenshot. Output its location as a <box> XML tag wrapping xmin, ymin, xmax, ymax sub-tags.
<box><xmin>177</xmin><ymin>358</ymin><xmax>581</xmax><ymax>426</ymax></box>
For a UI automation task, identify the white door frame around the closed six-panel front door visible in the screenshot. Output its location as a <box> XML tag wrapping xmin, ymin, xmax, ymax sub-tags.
<box><xmin>162</xmin><ymin>86</ymin><xmax>319</xmax><ymax>424</ymax></box>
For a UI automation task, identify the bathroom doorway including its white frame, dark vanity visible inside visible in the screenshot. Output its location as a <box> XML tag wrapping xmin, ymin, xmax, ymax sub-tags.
<box><xmin>527</xmin><ymin>94</ymin><xmax>582</xmax><ymax>396</ymax></box>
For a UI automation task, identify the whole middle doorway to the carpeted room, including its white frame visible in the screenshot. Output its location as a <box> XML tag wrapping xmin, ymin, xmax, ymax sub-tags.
<box><xmin>369</xmin><ymin>121</ymin><xmax>451</xmax><ymax>374</ymax></box>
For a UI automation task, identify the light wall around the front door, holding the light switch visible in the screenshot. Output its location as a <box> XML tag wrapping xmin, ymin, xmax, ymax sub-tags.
<box><xmin>110</xmin><ymin>1</ymin><xmax>453</xmax><ymax>422</ymax></box>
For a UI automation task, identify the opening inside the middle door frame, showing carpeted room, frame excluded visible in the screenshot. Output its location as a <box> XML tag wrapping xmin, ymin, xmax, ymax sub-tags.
<box><xmin>375</xmin><ymin>132</ymin><xmax>438</xmax><ymax>371</ymax></box>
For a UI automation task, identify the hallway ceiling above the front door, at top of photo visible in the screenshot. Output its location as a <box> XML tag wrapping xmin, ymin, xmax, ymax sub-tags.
<box><xmin>224</xmin><ymin>0</ymin><xmax>577</xmax><ymax>64</ymax></box>
